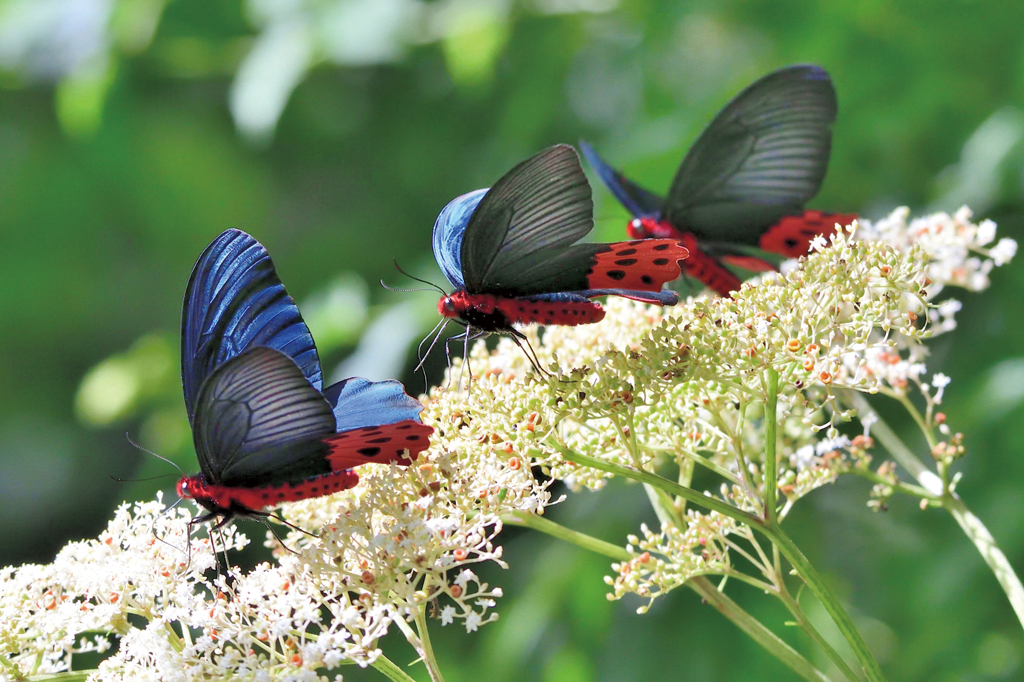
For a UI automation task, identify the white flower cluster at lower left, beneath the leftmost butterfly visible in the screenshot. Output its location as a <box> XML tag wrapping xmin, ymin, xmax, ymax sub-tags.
<box><xmin>0</xmin><ymin>440</ymin><xmax>547</xmax><ymax>681</ymax></box>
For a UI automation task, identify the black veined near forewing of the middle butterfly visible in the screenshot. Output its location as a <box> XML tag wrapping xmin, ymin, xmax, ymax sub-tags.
<box><xmin>461</xmin><ymin>144</ymin><xmax>602</xmax><ymax>296</ymax></box>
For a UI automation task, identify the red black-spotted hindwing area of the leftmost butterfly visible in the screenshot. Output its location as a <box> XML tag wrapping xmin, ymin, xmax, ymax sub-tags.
<box><xmin>324</xmin><ymin>419</ymin><xmax>434</xmax><ymax>471</ymax></box>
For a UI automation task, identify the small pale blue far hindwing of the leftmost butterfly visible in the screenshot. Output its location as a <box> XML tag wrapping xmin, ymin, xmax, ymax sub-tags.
<box><xmin>324</xmin><ymin>377</ymin><xmax>423</xmax><ymax>431</ymax></box>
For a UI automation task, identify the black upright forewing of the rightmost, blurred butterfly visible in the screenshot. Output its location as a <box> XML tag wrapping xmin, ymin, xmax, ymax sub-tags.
<box><xmin>665</xmin><ymin>65</ymin><xmax>838</xmax><ymax>245</ymax></box>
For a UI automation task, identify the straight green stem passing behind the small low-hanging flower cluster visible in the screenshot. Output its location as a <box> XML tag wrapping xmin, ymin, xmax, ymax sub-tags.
<box><xmin>502</xmin><ymin>512</ymin><xmax>829</xmax><ymax>682</ymax></box>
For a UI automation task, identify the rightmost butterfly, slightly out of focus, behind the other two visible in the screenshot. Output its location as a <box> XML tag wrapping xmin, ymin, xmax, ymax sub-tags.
<box><xmin>580</xmin><ymin>65</ymin><xmax>857</xmax><ymax>296</ymax></box>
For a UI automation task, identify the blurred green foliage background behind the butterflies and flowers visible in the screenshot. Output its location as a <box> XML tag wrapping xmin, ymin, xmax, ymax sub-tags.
<box><xmin>0</xmin><ymin>0</ymin><xmax>1024</xmax><ymax>682</ymax></box>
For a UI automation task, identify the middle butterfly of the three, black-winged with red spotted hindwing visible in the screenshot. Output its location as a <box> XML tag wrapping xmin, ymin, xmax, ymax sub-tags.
<box><xmin>428</xmin><ymin>144</ymin><xmax>687</xmax><ymax>364</ymax></box>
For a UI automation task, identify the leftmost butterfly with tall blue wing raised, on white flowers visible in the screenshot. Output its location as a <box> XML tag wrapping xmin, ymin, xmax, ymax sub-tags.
<box><xmin>177</xmin><ymin>229</ymin><xmax>433</xmax><ymax>527</ymax></box>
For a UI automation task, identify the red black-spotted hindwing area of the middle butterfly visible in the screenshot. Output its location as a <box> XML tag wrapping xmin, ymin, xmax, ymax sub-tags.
<box><xmin>587</xmin><ymin>240</ymin><xmax>689</xmax><ymax>292</ymax></box>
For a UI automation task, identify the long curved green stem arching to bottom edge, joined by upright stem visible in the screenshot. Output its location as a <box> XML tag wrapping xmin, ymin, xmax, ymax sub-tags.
<box><xmin>556</xmin><ymin>445</ymin><xmax>885</xmax><ymax>682</ymax></box>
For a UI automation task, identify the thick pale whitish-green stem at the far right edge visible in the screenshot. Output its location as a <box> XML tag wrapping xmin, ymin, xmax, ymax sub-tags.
<box><xmin>850</xmin><ymin>392</ymin><xmax>1024</xmax><ymax>627</ymax></box>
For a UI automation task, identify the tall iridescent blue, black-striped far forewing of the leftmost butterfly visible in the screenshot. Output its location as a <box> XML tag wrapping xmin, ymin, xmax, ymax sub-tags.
<box><xmin>181</xmin><ymin>229</ymin><xmax>323</xmax><ymax>421</ymax></box>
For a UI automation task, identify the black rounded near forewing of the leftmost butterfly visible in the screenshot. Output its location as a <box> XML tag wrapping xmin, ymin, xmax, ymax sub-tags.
<box><xmin>193</xmin><ymin>346</ymin><xmax>335</xmax><ymax>486</ymax></box>
